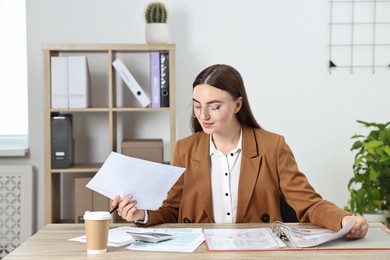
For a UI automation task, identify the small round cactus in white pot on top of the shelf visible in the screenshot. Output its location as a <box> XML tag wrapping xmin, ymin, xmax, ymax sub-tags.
<box><xmin>145</xmin><ymin>2</ymin><xmax>169</xmax><ymax>44</ymax></box>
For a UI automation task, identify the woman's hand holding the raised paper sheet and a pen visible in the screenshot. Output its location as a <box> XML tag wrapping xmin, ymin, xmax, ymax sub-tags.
<box><xmin>112</xmin><ymin>195</ymin><xmax>145</xmax><ymax>222</ymax></box>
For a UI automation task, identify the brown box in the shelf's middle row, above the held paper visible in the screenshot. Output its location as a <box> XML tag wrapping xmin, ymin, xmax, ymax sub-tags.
<box><xmin>122</xmin><ymin>139</ymin><xmax>164</xmax><ymax>163</ymax></box>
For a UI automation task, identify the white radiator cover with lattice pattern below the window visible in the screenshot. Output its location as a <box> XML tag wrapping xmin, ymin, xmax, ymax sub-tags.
<box><xmin>0</xmin><ymin>165</ymin><xmax>34</xmax><ymax>259</ymax></box>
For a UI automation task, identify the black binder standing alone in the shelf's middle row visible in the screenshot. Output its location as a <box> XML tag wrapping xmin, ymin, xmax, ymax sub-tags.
<box><xmin>51</xmin><ymin>114</ymin><xmax>74</xmax><ymax>169</ymax></box>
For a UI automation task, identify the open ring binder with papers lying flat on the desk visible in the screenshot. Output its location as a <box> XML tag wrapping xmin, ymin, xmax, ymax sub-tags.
<box><xmin>203</xmin><ymin>217</ymin><xmax>390</xmax><ymax>252</ymax></box>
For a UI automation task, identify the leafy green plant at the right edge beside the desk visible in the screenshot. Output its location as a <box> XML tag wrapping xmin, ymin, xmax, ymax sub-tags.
<box><xmin>345</xmin><ymin>120</ymin><xmax>390</xmax><ymax>222</ymax></box>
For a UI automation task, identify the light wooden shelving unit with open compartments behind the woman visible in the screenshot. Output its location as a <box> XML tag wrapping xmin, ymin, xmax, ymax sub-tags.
<box><xmin>42</xmin><ymin>43</ymin><xmax>176</xmax><ymax>223</ymax></box>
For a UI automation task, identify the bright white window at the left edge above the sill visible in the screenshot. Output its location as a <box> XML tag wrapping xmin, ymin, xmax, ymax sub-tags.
<box><xmin>0</xmin><ymin>0</ymin><xmax>28</xmax><ymax>138</ymax></box>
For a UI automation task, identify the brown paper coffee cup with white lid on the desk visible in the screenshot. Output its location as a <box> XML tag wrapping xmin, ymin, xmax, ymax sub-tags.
<box><xmin>84</xmin><ymin>211</ymin><xmax>111</xmax><ymax>254</ymax></box>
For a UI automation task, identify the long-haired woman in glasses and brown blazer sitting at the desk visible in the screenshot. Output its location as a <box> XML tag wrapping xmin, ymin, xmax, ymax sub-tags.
<box><xmin>112</xmin><ymin>64</ymin><xmax>368</xmax><ymax>238</ymax></box>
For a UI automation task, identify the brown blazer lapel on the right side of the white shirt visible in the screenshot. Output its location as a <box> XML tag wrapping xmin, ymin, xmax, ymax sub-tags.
<box><xmin>236</xmin><ymin>126</ymin><xmax>262</xmax><ymax>223</ymax></box>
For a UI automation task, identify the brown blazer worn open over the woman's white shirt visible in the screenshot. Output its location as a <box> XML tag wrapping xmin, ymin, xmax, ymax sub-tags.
<box><xmin>147</xmin><ymin>127</ymin><xmax>349</xmax><ymax>230</ymax></box>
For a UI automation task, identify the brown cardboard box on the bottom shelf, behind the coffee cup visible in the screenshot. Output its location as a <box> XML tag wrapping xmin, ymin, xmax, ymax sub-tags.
<box><xmin>74</xmin><ymin>178</ymin><xmax>111</xmax><ymax>223</ymax></box>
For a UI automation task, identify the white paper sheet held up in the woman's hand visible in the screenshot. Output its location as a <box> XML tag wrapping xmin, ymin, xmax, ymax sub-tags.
<box><xmin>86</xmin><ymin>152</ymin><xmax>185</xmax><ymax>210</ymax></box>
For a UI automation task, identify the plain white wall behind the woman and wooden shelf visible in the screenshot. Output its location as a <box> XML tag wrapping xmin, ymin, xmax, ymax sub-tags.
<box><xmin>27</xmin><ymin>0</ymin><xmax>390</xmax><ymax>232</ymax></box>
